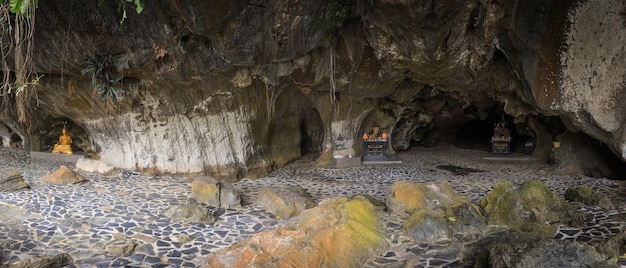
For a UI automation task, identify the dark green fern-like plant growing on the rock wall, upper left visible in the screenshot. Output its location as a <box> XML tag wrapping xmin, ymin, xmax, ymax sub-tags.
<box><xmin>81</xmin><ymin>53</ymin><xmax>124</xmax><ymax>103</ymax></box>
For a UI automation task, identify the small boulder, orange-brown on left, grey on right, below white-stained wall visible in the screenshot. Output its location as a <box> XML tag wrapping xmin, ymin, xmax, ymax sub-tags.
<box><xmin>191</xmin><ymin>176</ymin><xmax>242</xmax><ymax>209</ymax></box>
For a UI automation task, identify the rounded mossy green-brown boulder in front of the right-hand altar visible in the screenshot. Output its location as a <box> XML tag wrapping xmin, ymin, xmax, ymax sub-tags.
<box><xmin>480</xmin><ymin>180</ymin><xmax>575</xmax><ymax>237</ymax></box>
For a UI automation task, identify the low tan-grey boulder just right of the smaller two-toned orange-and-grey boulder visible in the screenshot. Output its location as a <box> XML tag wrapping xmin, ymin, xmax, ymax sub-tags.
<box><xmin>254</xmin><ymin>186</ymin><xmax>315</xmax><ymax>219</ymax></box>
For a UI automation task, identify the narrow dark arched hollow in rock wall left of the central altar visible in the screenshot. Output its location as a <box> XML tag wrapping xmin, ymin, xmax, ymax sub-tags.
<box><xmin>300</xmin><ymin>108</ymin><xmax>324</xmax><ymax>156</ymax></box>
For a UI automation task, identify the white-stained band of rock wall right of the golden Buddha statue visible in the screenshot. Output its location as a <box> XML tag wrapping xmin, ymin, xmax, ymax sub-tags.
<box><xmin>86</xmin><ymin>109</ymin><xmax>255</xmax><ymax>173</ymax></box>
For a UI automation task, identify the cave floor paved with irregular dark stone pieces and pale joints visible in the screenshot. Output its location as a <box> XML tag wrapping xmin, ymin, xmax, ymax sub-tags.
<box><xmin>0</xmin><ymin>146</ymin><xmax>626</xmax><ymax>267</ymax></box>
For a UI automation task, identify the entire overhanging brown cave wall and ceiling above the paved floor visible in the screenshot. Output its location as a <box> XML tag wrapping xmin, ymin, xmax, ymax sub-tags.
<box><xmin>0</xmin><ymin>0</ymin><xmax>626</xmax><ymax>180</ymax></box>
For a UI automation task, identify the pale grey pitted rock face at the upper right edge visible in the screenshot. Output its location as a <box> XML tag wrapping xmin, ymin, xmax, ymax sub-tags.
<box><xmin>546</xmin><ymin>0</ymin><xmax>626</xmax><ymax>159</ymax></box>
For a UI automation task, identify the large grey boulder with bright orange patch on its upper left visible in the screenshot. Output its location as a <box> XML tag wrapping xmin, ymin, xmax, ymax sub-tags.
<box><xmin>387</xmin><ymin>181</ymin><xmax>486</xmax><ymax>241</ymax></box>
